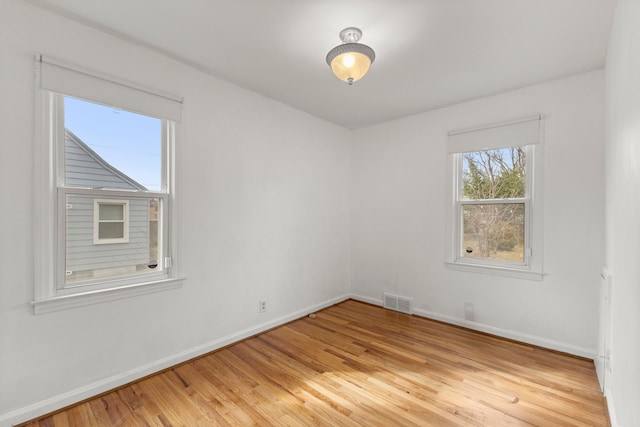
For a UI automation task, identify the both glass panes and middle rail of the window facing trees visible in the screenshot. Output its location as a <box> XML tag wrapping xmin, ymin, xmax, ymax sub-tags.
<box><xmin>456</xmin><ymin>147</ymin><xmax>529</xmax><ymax>265</ymax></box>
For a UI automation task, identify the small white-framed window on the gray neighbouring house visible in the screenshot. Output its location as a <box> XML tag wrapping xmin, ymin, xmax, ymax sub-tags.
<box><xmin>93</xmin><ymin>200</ymin><xmax>129</xmax><ymax>245</ymax></box>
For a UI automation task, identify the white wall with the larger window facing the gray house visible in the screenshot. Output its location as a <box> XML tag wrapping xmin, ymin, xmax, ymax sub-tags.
<box><xmin>0</xmin><ymin>0</ymin><xmax>350</xmax><ymax>425</ymax></box>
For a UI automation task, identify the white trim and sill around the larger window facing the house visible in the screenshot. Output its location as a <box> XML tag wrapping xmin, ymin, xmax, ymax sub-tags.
<box><xmin>31</xmin><ymin>55</ymin><xmax>184</xmax><ymax>314</ymax></box>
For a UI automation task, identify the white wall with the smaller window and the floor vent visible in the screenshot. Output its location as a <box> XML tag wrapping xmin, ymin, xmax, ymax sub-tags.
<box><xmin>352</xmin><ymin>71</ymin><xmax>604</xmax><ymax>357</ymax></box>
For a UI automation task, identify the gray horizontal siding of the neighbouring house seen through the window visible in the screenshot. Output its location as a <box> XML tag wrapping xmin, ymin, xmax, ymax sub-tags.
<box><xmin>65</xmin><ymin>130</ymin><xmax>150</xmax><ymax>274</ymax></box>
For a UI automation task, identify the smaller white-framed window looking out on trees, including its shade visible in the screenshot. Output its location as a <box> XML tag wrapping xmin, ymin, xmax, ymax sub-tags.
<box><xmin>447</xmin><ymin>116</ymin><xmax>542</xmax><ymax>279</ymax></box>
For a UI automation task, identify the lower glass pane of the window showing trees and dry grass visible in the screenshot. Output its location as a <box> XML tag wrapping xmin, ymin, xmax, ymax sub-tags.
<box><xmin>461</xmin><ymin>203</ymin><xmax>525</xmax><ymax>263</ymax></box>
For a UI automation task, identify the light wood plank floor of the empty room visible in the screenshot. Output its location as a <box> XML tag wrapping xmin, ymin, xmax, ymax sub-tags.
<box><xmin>21</xmin><ymin>301</ymin><xmax>609</xmax><ymax>427</ymax></box>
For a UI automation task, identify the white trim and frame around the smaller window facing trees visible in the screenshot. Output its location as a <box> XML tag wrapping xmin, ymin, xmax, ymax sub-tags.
<box><xmin>445</xmin><ymin>116</ymin><xmax>545</xmax><ymax>280</ymax></box>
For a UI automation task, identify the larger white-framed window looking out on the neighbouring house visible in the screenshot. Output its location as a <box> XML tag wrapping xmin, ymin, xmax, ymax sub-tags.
<box><xmin>33</xmin><ymin>56</ymin><xmax>181</xmax><ymax>313</ymax></box>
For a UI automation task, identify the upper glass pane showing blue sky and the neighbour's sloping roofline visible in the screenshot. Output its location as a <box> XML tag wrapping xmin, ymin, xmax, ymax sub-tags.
<box><xmin>64</xmin><ymin>96</ymin><xmax>162</xmax><ymax>191</ymax></box>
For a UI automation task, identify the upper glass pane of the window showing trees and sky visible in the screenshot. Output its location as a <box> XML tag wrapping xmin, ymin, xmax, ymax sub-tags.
<box><xmin>462</xmin><ymin>147</ymin><xmax>525</xmax><ymax>200</ymax></box>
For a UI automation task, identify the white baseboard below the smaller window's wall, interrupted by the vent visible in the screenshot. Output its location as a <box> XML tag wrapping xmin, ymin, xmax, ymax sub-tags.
<box><xmin>351</xmin><ymin>294</ymin><xmax>596</xmax><ymax>360</ymax></box>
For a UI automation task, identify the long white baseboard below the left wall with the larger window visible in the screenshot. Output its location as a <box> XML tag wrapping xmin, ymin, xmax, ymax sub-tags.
<box><xmin>0</xmin><ymin>294</ymin><xmax>351</xmax><ymax>427</ymax></box>
